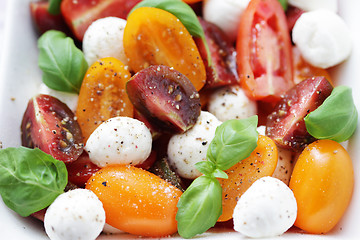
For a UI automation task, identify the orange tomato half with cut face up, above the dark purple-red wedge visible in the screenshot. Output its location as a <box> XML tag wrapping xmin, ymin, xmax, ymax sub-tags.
<box><xmin>124</xmin><ymin>7</ymin><xmax>206</xmax><ymax>91</ymax></box>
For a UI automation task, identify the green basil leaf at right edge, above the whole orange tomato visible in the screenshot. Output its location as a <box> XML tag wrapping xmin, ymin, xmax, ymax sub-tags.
<box><xmin>305</xmin><ymin>86</ymin><xmax>358</xmax><ymax>142</ymax></box>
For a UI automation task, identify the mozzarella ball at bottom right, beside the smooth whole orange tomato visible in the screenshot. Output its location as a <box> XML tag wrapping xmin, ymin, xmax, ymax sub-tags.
<box><xmin>233</xmin><ymin>177</ymin><xmax>297</xmax><ymax>238</ymax></box>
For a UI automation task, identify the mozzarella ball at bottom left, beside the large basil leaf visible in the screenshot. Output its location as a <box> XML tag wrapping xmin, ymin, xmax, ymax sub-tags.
<box><xmin>44</xmin><ymin>188</ymin><xmax>105</xmax><ymax>240</ymax></box>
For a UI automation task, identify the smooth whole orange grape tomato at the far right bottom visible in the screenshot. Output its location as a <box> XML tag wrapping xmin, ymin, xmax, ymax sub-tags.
<box><xmin>289</xmin><ymin>140</ymin><xmax>354</xmax><ymax>234</ymax></box>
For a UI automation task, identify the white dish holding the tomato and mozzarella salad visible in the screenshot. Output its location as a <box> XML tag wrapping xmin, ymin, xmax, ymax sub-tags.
<box><xmin>0</xmin><ymin>0</ymin><xmax>360</xmax><ymax>240</ymax></box>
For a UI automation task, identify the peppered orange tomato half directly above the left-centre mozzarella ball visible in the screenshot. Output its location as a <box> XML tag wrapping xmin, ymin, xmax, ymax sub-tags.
<box><xmin>76</xmin><ymin>57</ymin><xmax>134</xmax><ymax>142</ymax></box>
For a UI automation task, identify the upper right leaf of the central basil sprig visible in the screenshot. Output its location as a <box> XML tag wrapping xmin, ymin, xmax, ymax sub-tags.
<box><xmin>206</xmin><ymin>115</ymin><xmax>258</xmax><ymax>170</ymax></box>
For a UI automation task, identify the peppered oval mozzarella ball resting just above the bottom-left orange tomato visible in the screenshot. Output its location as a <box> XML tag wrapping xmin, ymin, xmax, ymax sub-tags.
<box><xmin>85</xmin><ymin>117</ymin><xmax>152</xmax><ymax>167</ymax></box>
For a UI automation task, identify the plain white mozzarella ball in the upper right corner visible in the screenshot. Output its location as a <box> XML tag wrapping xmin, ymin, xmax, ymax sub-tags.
<box><xmin>292</xmin><ymin>10</ymin><xmax>352</xmax><ymax>68</ymax></box>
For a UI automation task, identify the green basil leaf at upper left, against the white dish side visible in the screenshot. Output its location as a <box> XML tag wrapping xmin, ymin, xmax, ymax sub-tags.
<box><xmin>38</xmin><ymin>30</ymin><xmax>88</xmax><ymax>93</ymax></box>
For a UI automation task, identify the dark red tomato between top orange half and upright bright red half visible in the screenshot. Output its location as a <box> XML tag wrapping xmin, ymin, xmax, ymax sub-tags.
<box><xmin>195</xmin><ymin>18</ymin><xmax>239</xmax><ymax>87</ymax></box>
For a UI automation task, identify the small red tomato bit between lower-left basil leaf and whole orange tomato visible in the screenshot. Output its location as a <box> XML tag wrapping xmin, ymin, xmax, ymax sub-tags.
<box><xmin>66</xmin><ymin>152</ymin><xmax>100</xmax><ymax>187</ymax></box>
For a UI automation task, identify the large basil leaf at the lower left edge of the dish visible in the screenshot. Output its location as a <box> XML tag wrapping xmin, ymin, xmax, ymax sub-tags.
<box><xmin>0</xmin><ymin>147</ymin><xmax>67</xmax><ymax>217</ymax></box>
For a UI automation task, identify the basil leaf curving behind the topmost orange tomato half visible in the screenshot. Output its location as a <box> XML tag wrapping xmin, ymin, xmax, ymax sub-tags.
<box><xmin>129</xmin><ymin>0</ymin><xmax>212</xmax><ymax>66</ymax></box>
